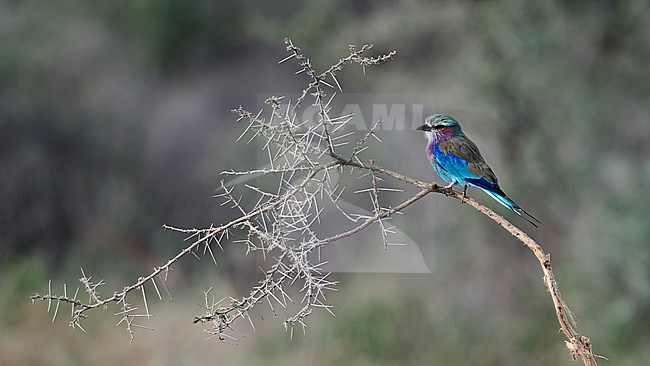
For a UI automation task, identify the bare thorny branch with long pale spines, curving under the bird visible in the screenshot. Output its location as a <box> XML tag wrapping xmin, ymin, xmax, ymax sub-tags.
<box><xmin>31</xmin><ymin>39</ymin><xmax>596</xmax><ymax>365</ymax></box>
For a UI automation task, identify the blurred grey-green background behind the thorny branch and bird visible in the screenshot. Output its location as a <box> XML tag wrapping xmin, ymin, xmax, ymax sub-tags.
<box><xmin>0</xmin><ymin>0</ymin><xmax>650</xmax><ymax>365</ymax></box>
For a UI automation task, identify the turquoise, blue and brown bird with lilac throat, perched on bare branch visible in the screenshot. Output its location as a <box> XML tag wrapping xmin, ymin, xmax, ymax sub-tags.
<box><xmin>416</xmin><ymin>114</ymin><xmax>543</xmax><ymax>227</ymax></box>
